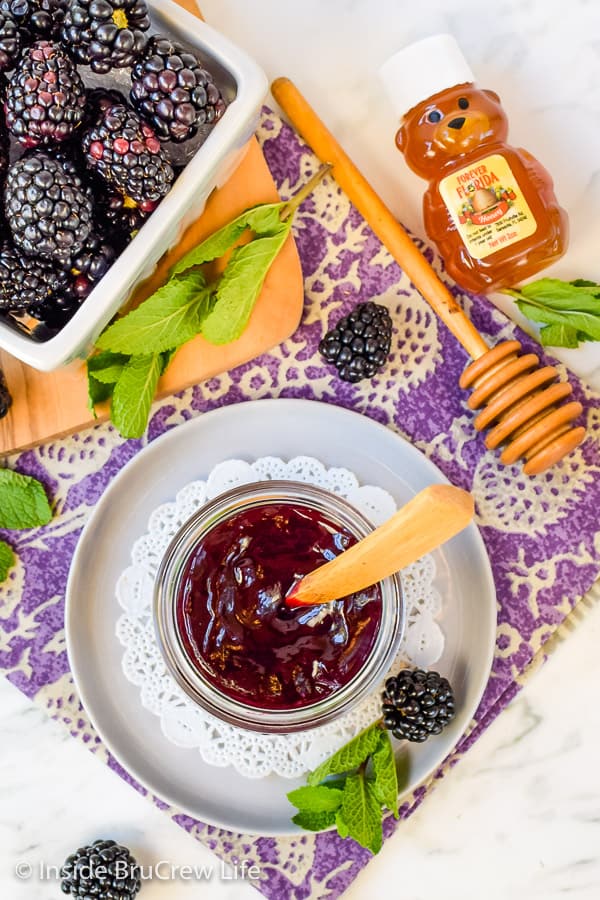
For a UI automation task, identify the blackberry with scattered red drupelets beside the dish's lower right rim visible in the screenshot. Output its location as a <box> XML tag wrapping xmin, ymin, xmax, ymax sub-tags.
<box><xmin>82</xmin><ymin>104</ymin><xmax>175</xmax><ymax>212</ymax></box>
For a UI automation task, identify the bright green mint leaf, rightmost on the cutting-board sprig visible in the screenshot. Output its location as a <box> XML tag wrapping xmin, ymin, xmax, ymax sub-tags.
<box><xmin>202</xmin><ymin>219</ymin><xmax>292</xmax><ymax>344</ymax></box>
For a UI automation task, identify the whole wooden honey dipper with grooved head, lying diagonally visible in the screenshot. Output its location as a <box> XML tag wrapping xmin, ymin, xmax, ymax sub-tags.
<box><xmin>271</xmin><ymin>78</ymin><xmax>585</xmax><ymax>475</ymax></box>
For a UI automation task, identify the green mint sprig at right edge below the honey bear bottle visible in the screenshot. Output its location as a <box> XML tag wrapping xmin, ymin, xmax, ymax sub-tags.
<box><xmin>504</xmin><ymin>278</ymin><xmax>600</xmax><ymax>348</ymax></box>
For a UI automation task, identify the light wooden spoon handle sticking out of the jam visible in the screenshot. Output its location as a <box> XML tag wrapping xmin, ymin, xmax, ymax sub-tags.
<box><xmin>286</xmin><ymin>484</ymin><xmax>474</xmax><ymax>606</ymax></box>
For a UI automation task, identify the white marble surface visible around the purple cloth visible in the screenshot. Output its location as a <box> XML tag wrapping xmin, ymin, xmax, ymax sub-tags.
<box><xmin>0</xmin><ymin>0</ymin><xmax>600</xmax><ymax>900</ymax></box>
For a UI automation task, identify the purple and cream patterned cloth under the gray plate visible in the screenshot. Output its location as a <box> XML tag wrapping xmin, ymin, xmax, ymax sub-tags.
<box><xmin>0</xmin><ymin>110</ymin><xmax>600</xmax><ymax>900</ymax></box>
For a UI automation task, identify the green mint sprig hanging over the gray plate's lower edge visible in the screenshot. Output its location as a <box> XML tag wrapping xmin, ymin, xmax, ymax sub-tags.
<box><xmin>287</xmin><ymin>723</ymin><xmax>399</xmax><ymax>853</ymax></box>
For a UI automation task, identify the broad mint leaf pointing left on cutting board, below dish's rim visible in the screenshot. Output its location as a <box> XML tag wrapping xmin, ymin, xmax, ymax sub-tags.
<box><xmin>97</xmin><ymin>272</ymin><xmax>210</xmax><ymax>356</ymax></box>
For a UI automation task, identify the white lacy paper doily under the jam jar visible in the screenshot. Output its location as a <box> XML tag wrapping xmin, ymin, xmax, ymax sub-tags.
<box><xmin>116</xmin><ymin>456</ymin><xmax>444</xmax><ymax>778</ymax></box>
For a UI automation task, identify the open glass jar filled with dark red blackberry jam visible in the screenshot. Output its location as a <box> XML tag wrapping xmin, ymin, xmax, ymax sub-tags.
<box><xmin>155</xmin><ymin>481</ymin><xmax>403</xmax><ymax>732</ymax></box>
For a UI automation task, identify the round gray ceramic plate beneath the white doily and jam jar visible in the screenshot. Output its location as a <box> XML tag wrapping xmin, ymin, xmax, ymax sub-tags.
<box><xmin>66</xmin><ymin>400</ymin><xmax>496</xmax><ymax>834</ymax></box>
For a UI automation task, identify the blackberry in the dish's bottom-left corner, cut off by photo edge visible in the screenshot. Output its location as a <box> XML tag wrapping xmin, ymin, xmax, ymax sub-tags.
<box><xmin>0</xmin><ymin>242</ymin><xmax>72</xmax><ymax>318</ymax></box>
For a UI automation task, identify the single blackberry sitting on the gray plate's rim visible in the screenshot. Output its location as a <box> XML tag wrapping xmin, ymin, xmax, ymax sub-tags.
<box><xmin>382</xmin><ymin>669</ymin><xmax>455</xmax><ymax>743</ymax></box>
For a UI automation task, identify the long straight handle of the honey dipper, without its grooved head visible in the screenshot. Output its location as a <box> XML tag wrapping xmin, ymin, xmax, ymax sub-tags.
<box><xmin>271</xmin><ymin>78</ymin><xmax>489</xmax><ymax>359</ymax></box>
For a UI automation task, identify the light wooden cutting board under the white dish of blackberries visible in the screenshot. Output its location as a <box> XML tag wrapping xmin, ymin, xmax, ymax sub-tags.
<box><xmin>0</xmin><ymin>0</ymin><xmax>304</xmax><ymax>456</ymax></box>
